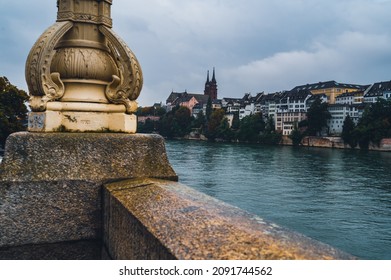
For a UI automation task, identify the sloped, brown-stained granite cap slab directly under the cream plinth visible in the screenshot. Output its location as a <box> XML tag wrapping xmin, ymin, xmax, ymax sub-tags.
<box><xmin>0</xmin><ymin>132</ymin><xmax>177</xmax><ymax>182</ymax></box>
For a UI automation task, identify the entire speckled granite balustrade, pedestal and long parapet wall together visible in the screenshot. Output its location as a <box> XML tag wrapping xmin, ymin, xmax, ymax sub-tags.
<box><xmin>0</xmin><ymin>132</ymin><xmax>354</xmax><ymax>260</ymax></box>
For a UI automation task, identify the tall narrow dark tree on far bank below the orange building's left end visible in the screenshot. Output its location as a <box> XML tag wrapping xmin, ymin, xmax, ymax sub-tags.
<box><xmin>307</xmin><ymin>96</ymin><xmax>331</xmax><ymax>136</ymax></box>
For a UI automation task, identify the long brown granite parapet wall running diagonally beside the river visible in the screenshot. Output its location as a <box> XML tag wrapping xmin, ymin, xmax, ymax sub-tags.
<box><xmin>104</xmin><ymin>179</ymin><xmax>353</xmax><ymax>260</ymax></box>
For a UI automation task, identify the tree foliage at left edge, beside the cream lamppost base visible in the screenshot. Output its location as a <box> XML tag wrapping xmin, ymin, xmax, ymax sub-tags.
<box><xmin>0</xmin><ymin>77</ymin><xmax>28</xmax><ymax>146</ymax></box>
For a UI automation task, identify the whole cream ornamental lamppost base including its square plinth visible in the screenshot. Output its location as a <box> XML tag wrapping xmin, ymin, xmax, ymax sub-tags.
<box><xmin>26</xmin><ymin>0</ymin><xmax>143</xmax><ymax>133</ymax></box>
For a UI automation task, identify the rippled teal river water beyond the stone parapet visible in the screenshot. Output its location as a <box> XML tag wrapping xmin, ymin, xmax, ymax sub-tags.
<box><xmin>166</xmin><ymin>141</ymin><xmax>391</xmax><ymax>260</ymax></box>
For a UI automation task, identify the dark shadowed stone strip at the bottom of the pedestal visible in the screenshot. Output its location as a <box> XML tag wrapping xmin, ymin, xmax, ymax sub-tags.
<box><xmin>0</xmin><ymin>240</ymin><xmax>102</xmax><ymax>260</ymax></box>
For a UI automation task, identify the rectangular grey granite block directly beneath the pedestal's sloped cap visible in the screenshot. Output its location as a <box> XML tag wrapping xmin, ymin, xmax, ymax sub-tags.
<box><xmin>0</xmin><ymin>180</ymin><xmax>102</xmax><ymax>247</ymax></box>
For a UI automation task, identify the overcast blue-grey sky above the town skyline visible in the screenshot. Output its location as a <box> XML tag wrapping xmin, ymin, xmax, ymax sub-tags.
<box><xmin>0</xmin><ymin>0</ymin><xmax>391</xmax><ymax>106</ymax></box>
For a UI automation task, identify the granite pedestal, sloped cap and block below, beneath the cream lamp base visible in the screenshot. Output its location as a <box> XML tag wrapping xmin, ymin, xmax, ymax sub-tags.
<box><xmin>0</xmin><ymin>132</ymin><xmax>177</xmax><ymax>255</ymax></box>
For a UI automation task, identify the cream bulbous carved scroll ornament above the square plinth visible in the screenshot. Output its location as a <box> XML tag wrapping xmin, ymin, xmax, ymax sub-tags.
<box><xmin>25</xmin><ymin>0</ymin><xmax>143</xmax><ymax>114</ymax></box>
